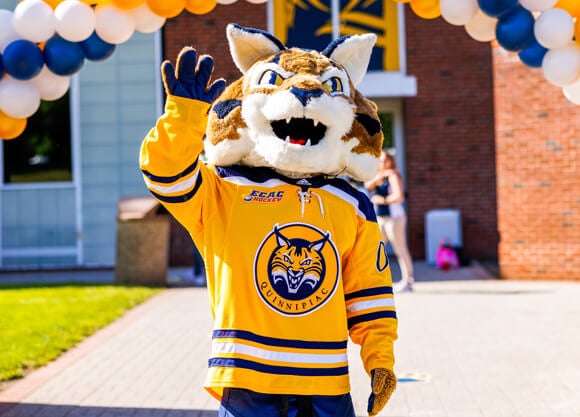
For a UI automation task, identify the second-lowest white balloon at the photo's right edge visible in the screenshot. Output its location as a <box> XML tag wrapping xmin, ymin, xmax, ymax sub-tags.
<box><xmin>542</xmin><ymin>43</ymin><xmax>580</xmax><ymax>87</ymax></box>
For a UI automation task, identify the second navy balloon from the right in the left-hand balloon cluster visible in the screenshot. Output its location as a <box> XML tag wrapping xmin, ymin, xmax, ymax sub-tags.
<box><xmin>44</xmin><ymin>35</ymin><xmax>85</xmax><ymax>76</ymax></box>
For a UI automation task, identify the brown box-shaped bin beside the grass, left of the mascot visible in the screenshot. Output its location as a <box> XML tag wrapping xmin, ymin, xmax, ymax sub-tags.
<box><xmin>115</xmin><ymin>197</ymin><xmax>169</xmax><ymax>286</ymax></box>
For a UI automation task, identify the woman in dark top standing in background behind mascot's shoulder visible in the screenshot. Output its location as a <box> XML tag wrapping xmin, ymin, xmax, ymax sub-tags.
<box><xmin>365</xmin><ymin>150</ymin><xmax>415</xmax><ymax>292</ymax></box>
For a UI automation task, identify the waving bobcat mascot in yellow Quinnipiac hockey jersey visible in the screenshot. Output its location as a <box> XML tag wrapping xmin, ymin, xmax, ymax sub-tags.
<box><xmin>140</xmin><ymin>24</ymin><xmax>397</xmax><ymax>417</ymax></box>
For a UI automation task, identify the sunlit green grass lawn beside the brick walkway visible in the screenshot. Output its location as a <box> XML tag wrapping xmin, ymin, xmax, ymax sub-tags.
<box><xmin>0</xmin><ymin>285</ymin><xmax>161</xmax><ymax>381</ymax></box>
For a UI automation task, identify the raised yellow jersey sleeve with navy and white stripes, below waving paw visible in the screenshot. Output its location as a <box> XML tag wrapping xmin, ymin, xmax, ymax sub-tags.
<box><xmin>140</xmin><ymin>95</ymin><xmax>218</xmax><ymax>235</ymax></box>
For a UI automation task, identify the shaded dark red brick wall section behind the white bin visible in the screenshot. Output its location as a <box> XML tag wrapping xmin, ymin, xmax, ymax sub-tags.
<box><xmin>404</xmin><ymin>13</ymin><xmax>498</xmax><ymax>260</ymax></box>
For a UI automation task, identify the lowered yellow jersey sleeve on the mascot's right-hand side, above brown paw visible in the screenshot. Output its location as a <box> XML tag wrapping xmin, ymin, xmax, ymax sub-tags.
<box><xmin>343</xmin><ymin>219</ymin><xmax>397</xmax><ymax>374</ymax></box>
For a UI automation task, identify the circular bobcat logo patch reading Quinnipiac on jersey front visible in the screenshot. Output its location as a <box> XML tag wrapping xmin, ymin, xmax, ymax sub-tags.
<box><xmin>254</xmin><ymin>223</ymin><xmax>340</xmax><ymax>316</ymax></box>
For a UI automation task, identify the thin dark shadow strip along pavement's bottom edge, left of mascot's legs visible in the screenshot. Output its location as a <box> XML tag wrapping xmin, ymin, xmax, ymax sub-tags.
<box><xmin>0</xmin><ymin>403</ymin><xmax>217</xmax><ymax>417</ymax></box>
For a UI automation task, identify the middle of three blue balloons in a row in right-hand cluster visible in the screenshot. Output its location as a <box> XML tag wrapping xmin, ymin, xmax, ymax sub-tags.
<box><xmin>495</xmin><ymin>6</ymin><xmax>535</xmax><ymax>52</ymax></box>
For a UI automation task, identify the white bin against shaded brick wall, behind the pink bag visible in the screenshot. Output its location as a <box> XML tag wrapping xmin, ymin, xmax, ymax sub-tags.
<box><xmin>425</xmin><ymin>209</ymin><xmax>463</xmax><ymax>265</ymax></box>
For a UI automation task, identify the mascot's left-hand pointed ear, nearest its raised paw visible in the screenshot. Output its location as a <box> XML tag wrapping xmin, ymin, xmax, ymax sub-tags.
<box><xmin>226</xmin><ymin>23</ymin><xmax>286</xmax><ymax>74</ymax></box>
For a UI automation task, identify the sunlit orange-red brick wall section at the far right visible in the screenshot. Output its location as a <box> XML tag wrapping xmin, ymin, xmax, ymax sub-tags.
<box><xmin>493</xmin><ymin>47</ymin><xmax>580</xmax><ymax>281</ymax></box>
